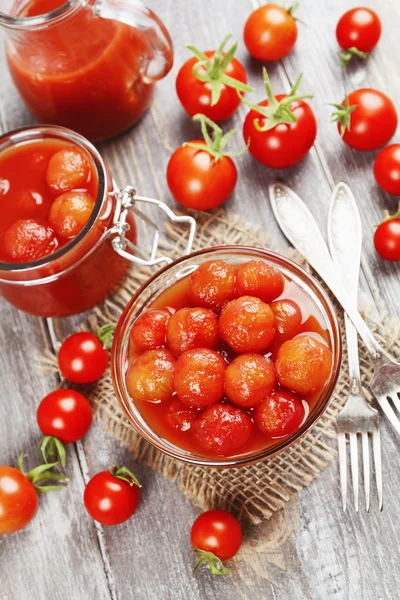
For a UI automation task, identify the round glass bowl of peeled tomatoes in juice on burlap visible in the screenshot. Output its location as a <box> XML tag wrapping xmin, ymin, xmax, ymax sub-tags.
<box><xmin>111</xmin><ymin>246</ymin><xmax>341</xmax><ymax>467</ymax></box>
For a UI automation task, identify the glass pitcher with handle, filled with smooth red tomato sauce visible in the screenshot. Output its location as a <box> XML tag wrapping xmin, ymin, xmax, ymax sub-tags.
<box><xmin>0</xmin><ymin>0</ymin><xmax>173</xmax><ymax>140</ymax></box>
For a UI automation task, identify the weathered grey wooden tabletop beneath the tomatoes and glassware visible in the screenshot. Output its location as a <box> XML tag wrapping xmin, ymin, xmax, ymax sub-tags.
<box><xmin>0</xmin><ymin>0</ymin><xmax>400</xmax><ymax>600</ymax></box>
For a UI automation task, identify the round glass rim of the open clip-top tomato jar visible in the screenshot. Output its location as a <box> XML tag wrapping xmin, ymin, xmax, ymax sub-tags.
<box><xmin>0</xmin><ymin>125</ymin><xmax>108</xmax><ymax>273</ymax></box>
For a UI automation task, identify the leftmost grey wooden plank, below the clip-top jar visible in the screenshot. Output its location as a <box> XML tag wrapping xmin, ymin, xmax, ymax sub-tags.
<box><xmin>0</xmin><ymin>301</ymin><xmax>110</xmax><ymax>600</ymax></box>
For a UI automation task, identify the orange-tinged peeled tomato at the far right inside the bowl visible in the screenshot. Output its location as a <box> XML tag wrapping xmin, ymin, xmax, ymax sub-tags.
<box><xmin>275</xmin><ymin>334</ymin><xmax>332</xmax><ymax>394</ymax></box>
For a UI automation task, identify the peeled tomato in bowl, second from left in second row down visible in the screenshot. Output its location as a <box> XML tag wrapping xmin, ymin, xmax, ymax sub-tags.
<box><xmin>167</xmin><ymin>308</ymin><xmax>219</xmax><ymax>356</ymax></box>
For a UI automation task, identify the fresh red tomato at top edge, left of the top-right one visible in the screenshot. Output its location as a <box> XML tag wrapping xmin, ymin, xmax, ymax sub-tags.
<box><xmin>244</xmin><ymin>3</ymin><xmax>297</xmax><ymax>61</ymax></box>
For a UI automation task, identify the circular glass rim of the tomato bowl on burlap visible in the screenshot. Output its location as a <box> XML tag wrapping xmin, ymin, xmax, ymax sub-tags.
<box><xmin>110</xmin><ymin>245</ymin><xmax>342</xmax><ymax>468</ymax></box>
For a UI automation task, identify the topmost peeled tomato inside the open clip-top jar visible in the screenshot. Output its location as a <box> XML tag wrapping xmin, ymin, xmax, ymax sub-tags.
<box><xmin>46</xmin><ymin>148</ymin><xmax>90</xmax><ymax>194</ymax></box>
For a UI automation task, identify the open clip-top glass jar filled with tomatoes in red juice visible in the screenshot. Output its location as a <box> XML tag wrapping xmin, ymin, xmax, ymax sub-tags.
<box><xmin>0</xmin><ymin>126</ymin><xmax>136</xmax><ymax>317</ymax></box>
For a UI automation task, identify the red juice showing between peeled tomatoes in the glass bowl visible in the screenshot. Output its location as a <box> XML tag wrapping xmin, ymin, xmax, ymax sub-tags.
<box><xmin>129</xmin><ymin>268</ymin><xmax>330</xmax><ymax>458</ymax></box>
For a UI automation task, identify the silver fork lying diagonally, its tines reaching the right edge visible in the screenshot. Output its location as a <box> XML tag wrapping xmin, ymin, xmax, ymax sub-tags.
<box><xmin>269</xmin><ymin>182</ymin><xmax>400</xmax><ymax>433</ymax></box>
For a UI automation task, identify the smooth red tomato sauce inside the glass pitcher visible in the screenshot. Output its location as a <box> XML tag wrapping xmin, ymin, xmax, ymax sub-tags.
<box><xmin>7</xmin><ymin>0</ymin><xmax>154</xmax><ymax>140</ymax></box>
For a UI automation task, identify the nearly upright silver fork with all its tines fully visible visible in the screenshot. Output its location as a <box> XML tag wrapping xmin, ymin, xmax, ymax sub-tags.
<box><xmin>328</xmin><ymin>183</ymin><xmax>382</xmax><ymax>512</ymax></box>
